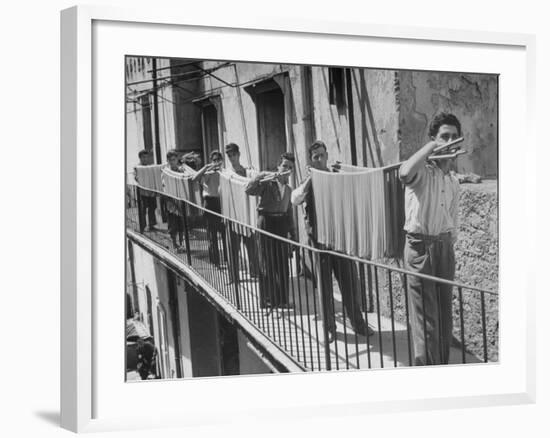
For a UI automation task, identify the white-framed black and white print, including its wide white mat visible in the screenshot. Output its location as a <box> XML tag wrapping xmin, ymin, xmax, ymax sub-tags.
<box><xmin>61</xmin><ymin>7</ymin><xmax>535</xmax><ymax>431</ymax></box>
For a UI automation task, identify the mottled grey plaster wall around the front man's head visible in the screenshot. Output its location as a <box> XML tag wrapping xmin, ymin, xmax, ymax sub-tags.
<box><xmin>398</xmin><ymin>71</ymin><xmax>498</xmax><ymax>177</ymax></box>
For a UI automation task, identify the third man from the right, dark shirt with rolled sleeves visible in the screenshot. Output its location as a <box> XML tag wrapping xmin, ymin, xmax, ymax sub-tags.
<box><xmin>246</xmin><ymin>152</ymin><xmax>296</xmax><ymax>316</ymax></box>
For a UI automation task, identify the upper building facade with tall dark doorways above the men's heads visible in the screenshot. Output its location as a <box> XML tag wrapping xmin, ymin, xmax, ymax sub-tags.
<box><xmin>126</xmin><ymin>57</ymin><xmax>498</xmax><ymax>178</ymax></box>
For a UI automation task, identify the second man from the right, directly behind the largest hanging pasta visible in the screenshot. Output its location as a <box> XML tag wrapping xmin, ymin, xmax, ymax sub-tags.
<box><xmin>292</xmin><ymin>141</ymin><xmax>374</xmax><ymax>342</ymax></box>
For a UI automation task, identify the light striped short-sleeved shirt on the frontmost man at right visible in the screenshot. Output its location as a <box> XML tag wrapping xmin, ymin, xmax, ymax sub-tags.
<box><xmin>403</xmin><ymin>163</ymin><xmax>460</xmax><ymax>241</ymax></box>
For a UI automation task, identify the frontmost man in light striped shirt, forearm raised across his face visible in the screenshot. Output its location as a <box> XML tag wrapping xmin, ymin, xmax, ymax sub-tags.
<box><xmin>399</xmin><ymin>113</ymin><xmax>461</xmax><ymax>365</ymax></box>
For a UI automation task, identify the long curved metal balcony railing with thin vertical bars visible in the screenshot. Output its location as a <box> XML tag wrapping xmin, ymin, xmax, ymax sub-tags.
<box><xmin>126</xmin><ymin>184</ymin><xmax>498</xmax><ymax>371</ymax></box>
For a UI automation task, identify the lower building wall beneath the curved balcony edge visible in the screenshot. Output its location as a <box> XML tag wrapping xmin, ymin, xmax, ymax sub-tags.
<box><xmin>126</xmin><ymin>240</ymin><xmax>278</xmax><ymax>379</ymax></box>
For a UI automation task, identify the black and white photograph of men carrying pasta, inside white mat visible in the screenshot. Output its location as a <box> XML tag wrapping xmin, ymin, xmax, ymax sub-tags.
<box><xmin>126</xmin><ymin>55</ymin><xmax>500</xmax><ymax>382</ymax></box>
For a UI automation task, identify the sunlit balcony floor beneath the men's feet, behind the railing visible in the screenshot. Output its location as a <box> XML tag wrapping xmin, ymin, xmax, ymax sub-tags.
<box><xmin>128</xmin><ymin>210</ymin><xmax>479</xmax><ymax>380</ymax></box>
